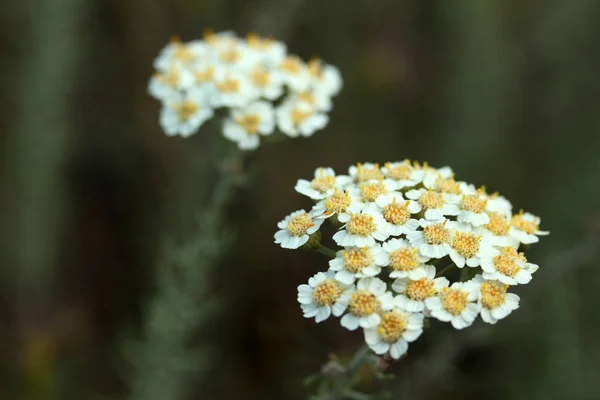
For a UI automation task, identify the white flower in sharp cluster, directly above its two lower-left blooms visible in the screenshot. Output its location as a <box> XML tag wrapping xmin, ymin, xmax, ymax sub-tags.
<box><xmin>329</xmin><ymin>244</ymin><xmax>386</xmax><ymax>285</ymax></box>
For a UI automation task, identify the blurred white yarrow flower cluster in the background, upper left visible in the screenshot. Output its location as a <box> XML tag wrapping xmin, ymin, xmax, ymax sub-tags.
<box><xmin>148</xmin><ymin>32</ymin><xmax>342</xmax><ymax>150</ymax></box>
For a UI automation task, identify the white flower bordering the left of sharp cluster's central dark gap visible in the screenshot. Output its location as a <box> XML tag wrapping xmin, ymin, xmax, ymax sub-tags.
<box><xmin>383</xmin><ymin>239</ymin><xmax>428</xmax><ymax>280</ymax></box>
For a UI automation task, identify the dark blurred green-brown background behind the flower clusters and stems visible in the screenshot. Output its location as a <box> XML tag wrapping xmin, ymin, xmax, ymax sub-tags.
<box><xmin>0</xmin><ymin>0</ymin><xmax>600</xmax><ymax>400</ymax></box>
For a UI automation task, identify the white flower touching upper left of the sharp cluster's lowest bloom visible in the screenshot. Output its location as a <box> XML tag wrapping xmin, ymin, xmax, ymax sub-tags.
<box><xmin>338</xmin><ymin>278</ymin><xmax>394</xmax><ymax>331</ymax></box>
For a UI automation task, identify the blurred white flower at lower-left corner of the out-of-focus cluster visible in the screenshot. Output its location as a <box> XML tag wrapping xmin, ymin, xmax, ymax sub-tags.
<box><xmin>160</xmin><ymin>90</ymin><xmax>213</xmax><ymax>137</ymax></box>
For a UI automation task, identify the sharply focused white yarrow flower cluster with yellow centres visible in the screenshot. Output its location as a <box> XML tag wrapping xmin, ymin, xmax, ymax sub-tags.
<box><xmin>275</xmin><ymin>160</ymin><xmax>548</xmax><ymax>359</ymax></box>
